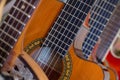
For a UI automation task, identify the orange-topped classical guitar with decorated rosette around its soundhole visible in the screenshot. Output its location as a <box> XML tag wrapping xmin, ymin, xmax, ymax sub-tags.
<box><xmin>24</xmin><ymin>0</ymin><xmax>117</xmax><ymax>80</ymax></box>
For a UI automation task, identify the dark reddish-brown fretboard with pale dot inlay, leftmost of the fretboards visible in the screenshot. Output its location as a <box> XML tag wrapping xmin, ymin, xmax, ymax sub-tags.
<box><xmin>0</xmin><ymin>0</ymin><xmax>39</xmax><ymax>67</ymax></box>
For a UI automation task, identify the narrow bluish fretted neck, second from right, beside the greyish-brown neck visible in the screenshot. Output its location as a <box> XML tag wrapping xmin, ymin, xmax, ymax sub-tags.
<box><xmin>82</xmin><ymin>0</ymin><xmax>118</xmax><ymax>59</ymax></box>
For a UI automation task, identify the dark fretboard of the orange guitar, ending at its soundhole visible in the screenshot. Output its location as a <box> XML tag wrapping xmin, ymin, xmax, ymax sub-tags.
<box><xmin>43</xmin><ymin>0</ymin><xmax>95</xmax><ymax>57</ymax></box>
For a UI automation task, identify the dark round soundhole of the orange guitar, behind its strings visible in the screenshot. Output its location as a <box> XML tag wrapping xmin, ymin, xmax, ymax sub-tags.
<box><xmin>32</xmin><ymin>47</ymin><xmax>63</xmax><ymax>80</ymax></box>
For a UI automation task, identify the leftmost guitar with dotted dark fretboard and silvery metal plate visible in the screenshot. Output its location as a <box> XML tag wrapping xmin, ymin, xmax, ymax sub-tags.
<box><xmin>0</xmin><ymin>0</ymin><xmax>47</xmax><ymax>80</ymax></box>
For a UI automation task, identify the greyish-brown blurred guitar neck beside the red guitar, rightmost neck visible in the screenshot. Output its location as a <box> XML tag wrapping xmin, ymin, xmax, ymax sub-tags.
<box><xmin>97</xmin><ymin>5</ymin><xmax>120</xmax><ymax>61</ymax></box>
